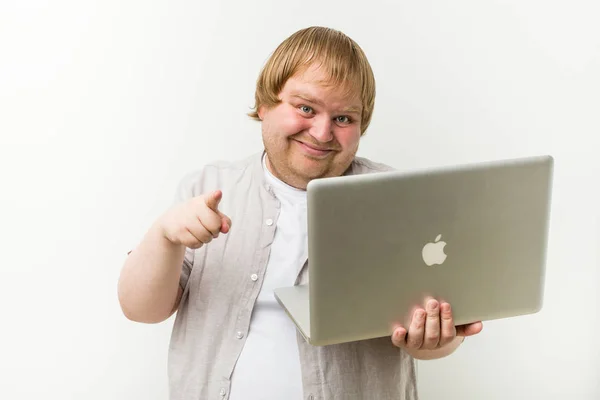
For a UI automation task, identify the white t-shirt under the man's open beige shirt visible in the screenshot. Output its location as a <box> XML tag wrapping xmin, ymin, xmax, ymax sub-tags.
<box><xmin>230</xmin><ymin>155</ymin><xmax>307</xmax><ymax>400</ymax></box>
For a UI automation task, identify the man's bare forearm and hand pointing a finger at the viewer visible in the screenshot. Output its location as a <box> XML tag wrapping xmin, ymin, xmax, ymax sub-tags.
<box><xmin>118</xmin><ymin>190</ymin><xmax>231</xmax><ymax>323</ymax></box>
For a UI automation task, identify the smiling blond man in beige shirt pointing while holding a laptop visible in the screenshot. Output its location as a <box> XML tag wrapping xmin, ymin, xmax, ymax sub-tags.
<box><xmin>119</xmin><ymin>27</ymin><xmax>482</xmax><ymax>400</ymax></box>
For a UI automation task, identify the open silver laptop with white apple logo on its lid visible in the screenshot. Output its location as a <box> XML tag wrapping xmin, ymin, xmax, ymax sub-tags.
<box><xmin>275</xmin><ymin>155</ymin><xmax>554</xmax><ymax>346</ymax></box>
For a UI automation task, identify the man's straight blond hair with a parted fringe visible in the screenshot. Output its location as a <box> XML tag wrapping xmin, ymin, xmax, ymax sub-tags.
<box><xmin>248</xmin><ymin>26</ymin><xmax>375</xmax><ymax>135</ymax></box>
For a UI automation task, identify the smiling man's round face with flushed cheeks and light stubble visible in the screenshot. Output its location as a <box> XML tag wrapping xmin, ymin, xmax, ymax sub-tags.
<box><xmin>258</xmin><ymin>67</ymin><xmax>362</xmax><ymax>189</ymax></box>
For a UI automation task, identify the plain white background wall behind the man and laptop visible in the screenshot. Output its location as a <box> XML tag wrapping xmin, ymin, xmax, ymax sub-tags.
<box><xmin>0</xmin><ymin>0</ymin><xmax>600</xmax><ymax>400</ymax></box>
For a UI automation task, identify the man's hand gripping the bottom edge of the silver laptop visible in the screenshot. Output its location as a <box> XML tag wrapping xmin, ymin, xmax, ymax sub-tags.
<box><xmin>392</xmin><ymin>298</ymin><xmax>483</xmax><ymax>352</ymax></box>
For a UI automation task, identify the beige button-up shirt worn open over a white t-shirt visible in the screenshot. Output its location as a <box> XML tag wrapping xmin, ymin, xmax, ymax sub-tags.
<box><xmin>168</xmin><ymin>153</ymin><xmax>417</xmax><ymax>400</ymax></box>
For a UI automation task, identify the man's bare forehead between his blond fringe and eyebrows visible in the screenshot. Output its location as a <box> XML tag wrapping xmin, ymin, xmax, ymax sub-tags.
<box><xmin>282</xmin><ymin>65</ymin><xmax>362</xmax><ymax>111</ymax></box>
